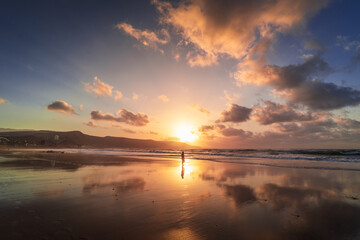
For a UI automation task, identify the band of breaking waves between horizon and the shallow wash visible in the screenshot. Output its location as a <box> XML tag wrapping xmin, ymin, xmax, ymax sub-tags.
<box><xmin>31</xmin><ymin>149</ymin><xmax>360</xmax><ymax>163</ymax></box>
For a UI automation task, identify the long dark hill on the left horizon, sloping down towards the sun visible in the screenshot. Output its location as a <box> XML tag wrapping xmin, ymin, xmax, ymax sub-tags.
<box><xmin>0</xmin><ymin>130</ymin><xmax>194</xmax><ymax>149</ymax></box>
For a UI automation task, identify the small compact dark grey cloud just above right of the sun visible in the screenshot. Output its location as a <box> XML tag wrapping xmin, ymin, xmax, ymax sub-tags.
<box><xmin>218</xmin><ymin>103</ymin><xmax>252</xmax><ymax>123</ymax></box>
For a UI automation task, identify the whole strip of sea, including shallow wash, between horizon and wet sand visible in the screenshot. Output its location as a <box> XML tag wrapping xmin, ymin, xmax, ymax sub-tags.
<box><xmin>21</xmin><ymin>148</ymin><xmax>360</xmax><ymax>171</ymax></box>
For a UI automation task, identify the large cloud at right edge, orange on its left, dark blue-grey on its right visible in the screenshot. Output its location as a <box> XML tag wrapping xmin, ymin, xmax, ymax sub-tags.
<box><xmin>236</xmin><ymin>54</ymin><xmax>360</xmax><ymax>110</ymax></box>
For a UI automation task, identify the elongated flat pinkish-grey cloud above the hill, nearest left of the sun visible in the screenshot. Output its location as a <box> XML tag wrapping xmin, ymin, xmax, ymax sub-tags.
<box><xmin>90</xmin><ymin>109</ymin><xmax>149</xmax><ymax>127</ymax></box>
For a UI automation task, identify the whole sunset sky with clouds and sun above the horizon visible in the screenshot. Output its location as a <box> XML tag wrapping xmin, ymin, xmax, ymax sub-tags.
<box><xmin>0</xmin><ymin>0</ymin><xmax>360</xmax><ymax>148</ymax></box>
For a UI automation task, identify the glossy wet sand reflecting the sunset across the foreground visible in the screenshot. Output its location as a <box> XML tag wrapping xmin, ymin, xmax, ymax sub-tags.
<box><xmin>0</xmin><ymin>150</ymin><xmax>360</xmax><ymax>239</ymax></box>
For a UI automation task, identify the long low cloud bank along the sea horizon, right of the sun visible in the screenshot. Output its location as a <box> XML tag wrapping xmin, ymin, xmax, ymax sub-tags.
<box><xmin>205</xmin><ymin>112</ymin><xmax>360</xmax><ymax>148</ymax></box>
